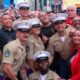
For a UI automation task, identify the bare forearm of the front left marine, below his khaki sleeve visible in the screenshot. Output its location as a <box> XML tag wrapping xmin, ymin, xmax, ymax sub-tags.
<box><xmin>3</xmin><ymin>63</ymin><xmax>18</xmax><ymax>80</ymax></box>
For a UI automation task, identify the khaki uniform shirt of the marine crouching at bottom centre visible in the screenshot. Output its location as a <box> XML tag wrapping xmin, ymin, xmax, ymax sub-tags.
<box><xmin>29</xmin><ymin>70</ymin><xmax>60</xmax><ymax>80</ymax></box>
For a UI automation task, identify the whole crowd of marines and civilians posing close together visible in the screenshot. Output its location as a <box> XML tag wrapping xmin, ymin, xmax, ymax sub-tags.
<box><xmin>0</xmin><ymin>2</ymin><xmax>80</xmax><ymax>80</ymax></box>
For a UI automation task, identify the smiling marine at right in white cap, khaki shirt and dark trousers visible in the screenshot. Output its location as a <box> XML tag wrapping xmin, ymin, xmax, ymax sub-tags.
<box><xmin>48</xmin><ymin>13</ymin><xmax>72</xmax><ymax>79</ymax></box>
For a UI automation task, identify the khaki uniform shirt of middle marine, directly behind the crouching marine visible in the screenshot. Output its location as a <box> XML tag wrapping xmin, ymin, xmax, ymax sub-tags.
<box><xmin>28</xmin><ymin>35</ymin><xmax>45</xmax><ymax>59</ymax></box>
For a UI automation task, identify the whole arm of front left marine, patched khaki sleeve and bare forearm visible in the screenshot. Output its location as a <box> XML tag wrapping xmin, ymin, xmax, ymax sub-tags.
<box><xmin>2</xmin><ymin>44</ymin><xmax>18</xmax><ymax>80</ymax></box>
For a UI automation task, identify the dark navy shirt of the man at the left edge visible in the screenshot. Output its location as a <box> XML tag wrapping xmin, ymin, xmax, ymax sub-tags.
<box><xmin>0</xmin><ymin>27</ymin><xmax>16</xmax><ymax>51</ymax></box>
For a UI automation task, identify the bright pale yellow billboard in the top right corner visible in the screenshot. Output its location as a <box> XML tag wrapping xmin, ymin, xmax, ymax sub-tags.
<box><xmin>62</xmin><ymin>0</ymin><xmax>80</xmax><ymax>10</ymax></box>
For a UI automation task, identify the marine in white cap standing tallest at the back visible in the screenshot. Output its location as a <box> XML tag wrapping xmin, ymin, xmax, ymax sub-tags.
<box><xmin>13</xmin><ymin>2</ymin><xmax>30</xmax><ymax>29</ymax></box>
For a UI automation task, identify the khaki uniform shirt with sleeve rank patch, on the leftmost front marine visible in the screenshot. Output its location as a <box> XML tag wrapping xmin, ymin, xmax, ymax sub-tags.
<box><xmin>2</xmin><ymin>39</ymin><xmax>27</xmax><ymax>75</ymax></box>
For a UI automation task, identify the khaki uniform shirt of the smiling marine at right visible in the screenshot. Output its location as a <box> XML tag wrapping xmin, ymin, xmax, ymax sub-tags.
<box><xmin>48</xmin><ymin>30</ymin><xmax>72</xmax><ymax>59</ymax></box>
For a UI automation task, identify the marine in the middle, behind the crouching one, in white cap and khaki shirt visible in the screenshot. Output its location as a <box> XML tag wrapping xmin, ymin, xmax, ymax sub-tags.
<box><xmin>28</xmin><ymin>18</ymin><xmax>45</xmax><ymax>71</ymax></box>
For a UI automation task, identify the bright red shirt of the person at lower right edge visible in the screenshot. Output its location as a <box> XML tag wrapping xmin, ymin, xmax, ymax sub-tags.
<box><xmin>71</xmin><ymin>50</ymin><xmax>80</xmax><ymax>80</ymax></box>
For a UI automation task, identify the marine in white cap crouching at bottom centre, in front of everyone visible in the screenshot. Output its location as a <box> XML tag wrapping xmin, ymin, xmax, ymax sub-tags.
<box><xmin>29</xmin><ymin>51</ymin><xmax>61</xmax><ymax>80</ymax></box>
